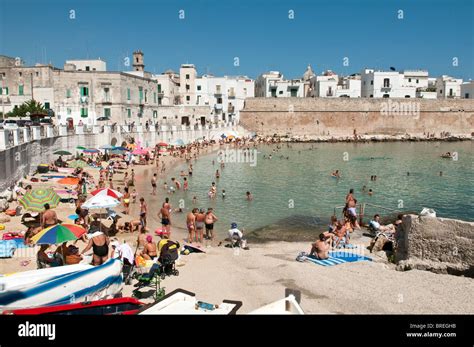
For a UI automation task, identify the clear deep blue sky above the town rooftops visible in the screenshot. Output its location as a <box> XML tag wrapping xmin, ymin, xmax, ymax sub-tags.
<box><xmin>0</xmin><ymin>0</ymin><xmax>474</xmax><ymax>79</ymax></box>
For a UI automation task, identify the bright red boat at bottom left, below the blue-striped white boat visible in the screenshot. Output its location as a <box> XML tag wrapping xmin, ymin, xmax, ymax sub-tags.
<box><xmin>2</xmin><ymin>298</ymin><xmax>145</xmax><ymax>316</ymax></box>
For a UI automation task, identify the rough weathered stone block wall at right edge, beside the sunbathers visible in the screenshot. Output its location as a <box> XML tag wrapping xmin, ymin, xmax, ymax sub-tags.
<box><xmin>395</xmin><ymin>215</ymin><xmax>474</xmax><ymax>277</ymax></box>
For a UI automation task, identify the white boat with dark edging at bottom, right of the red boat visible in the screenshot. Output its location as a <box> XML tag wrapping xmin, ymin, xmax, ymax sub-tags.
<box><xmin>138</xmin><ymin>289</ymin><xmax>242</xmax><ymax>315</ymax></box>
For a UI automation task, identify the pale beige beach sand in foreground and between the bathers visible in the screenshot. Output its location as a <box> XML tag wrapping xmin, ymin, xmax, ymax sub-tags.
<box><xmin>0</xmin><ymin>146</ymin><xmax>474</xmax><ymax>314</ymax></box>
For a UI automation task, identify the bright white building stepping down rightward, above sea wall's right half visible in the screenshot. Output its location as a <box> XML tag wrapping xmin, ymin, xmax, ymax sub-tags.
<box><xmin>361</xmin><ymin>69</ymin><xmax>416</xmax><ymax>98</ymax></box>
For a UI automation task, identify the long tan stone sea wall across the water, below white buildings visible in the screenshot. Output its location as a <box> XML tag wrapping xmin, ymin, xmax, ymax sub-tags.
<box><xmin>240</xmin><ymin>98</ymin><xmax>474</xmax><ymax>137</ymax></box>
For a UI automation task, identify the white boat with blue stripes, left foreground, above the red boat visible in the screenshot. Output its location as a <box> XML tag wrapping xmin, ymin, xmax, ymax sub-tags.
<box><xmin>0</xmin><ymin>259</ymin><xmax>123</xmax><ymax>309</ymax></box>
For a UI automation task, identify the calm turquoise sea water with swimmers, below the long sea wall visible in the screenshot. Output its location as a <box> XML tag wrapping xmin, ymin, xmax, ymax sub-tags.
<box><xmin>165</xmin><ymin>142</ymin><xmax>474</xmax><ymax>238</ymax></box>
